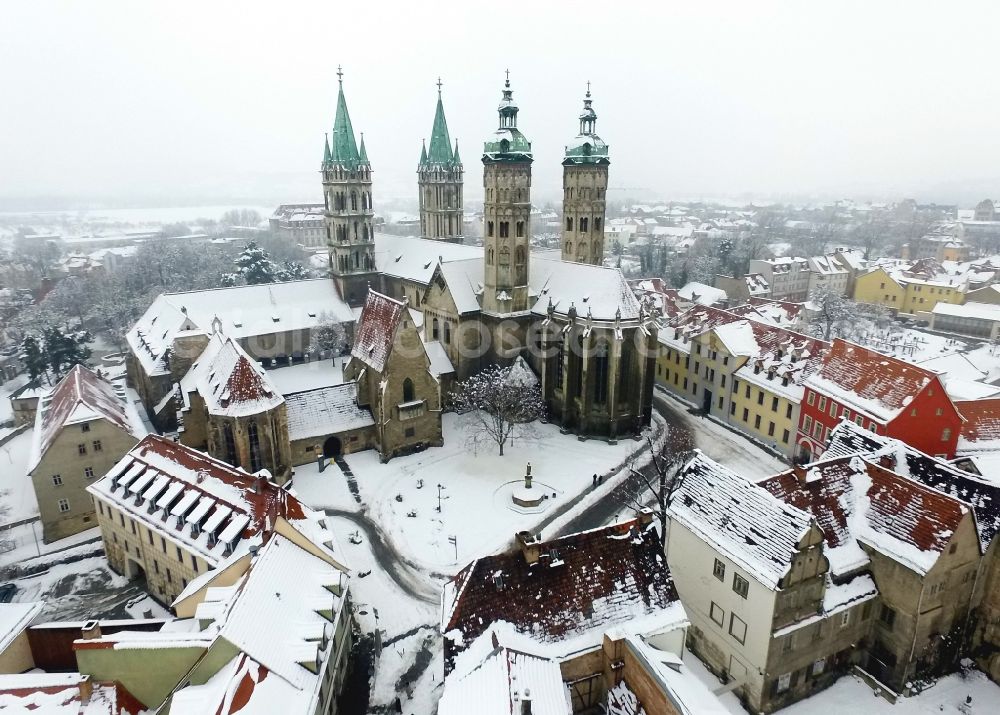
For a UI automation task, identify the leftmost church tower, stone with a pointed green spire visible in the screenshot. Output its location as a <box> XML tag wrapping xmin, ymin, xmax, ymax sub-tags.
<box><xmin>322</xmin><ymin>67</ymin><xmax>376</xmax><ymax>306</ymax></box>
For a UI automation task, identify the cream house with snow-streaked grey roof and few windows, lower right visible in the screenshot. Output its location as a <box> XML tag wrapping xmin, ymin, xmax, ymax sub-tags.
<box><xmin>667</xmin><ymin>453</ymin><xmax>876</xmax><ymax>712</ymax></box>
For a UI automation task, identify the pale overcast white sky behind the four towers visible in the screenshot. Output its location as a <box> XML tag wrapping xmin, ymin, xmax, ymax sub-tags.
<box><xmin>0</xmin><ymin>0</ymin><xmax>1000</xmax><ymax>210</ymax></box>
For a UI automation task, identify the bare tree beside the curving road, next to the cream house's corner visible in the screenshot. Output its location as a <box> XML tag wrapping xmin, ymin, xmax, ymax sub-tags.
<box><xmin>625</xmin><ymin>425</ymin><xmax>695</xmax><ymax>546</ymax></box>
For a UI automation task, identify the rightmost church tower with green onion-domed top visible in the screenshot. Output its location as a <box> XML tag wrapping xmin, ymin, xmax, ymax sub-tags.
<box><xmin>561</xmin><ymin>82</ymin><xmax>611</xmax><ymax>266</ymax></box>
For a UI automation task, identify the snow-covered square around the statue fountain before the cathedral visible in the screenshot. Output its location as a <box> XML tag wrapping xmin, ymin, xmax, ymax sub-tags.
<box><xmin>294</xmin><ymin>413</ymin><xmax>643</xmax><ymax>572</ymax></box>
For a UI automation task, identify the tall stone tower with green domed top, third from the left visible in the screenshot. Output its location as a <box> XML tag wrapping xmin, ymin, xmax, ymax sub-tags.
<box><xmin>482</xmin><ymin>71</ymin><xmax>532</xmax><ymax>314</ymax></box>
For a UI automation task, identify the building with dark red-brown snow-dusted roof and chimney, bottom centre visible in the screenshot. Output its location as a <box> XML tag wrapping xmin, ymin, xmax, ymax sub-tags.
<box><xmin>441</xmin><ymin>514</ymin><xmax>687</xmax><ymax>713</ymax></box>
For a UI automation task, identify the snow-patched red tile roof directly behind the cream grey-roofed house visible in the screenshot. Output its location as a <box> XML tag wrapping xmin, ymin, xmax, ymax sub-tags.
<box><xmin>760</xmin><ymin>456</ymin><xmax>970</xmax><ymax>576</ymax></box>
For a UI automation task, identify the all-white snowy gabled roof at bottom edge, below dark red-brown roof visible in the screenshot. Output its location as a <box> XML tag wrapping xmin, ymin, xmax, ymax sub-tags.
<box><xmin>437</xmin><ymin>629</ymin><xmax>573</xmax><ymax>715</ymax></box>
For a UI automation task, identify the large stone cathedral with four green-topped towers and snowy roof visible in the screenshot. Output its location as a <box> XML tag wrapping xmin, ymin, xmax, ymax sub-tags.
<box><xmin>340</xmin><ymin>73</ymin><xmax>656</xmax><ymax>442</ymax></box>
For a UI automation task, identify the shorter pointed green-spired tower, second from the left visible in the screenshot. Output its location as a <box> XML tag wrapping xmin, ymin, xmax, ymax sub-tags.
<box><xmin>417</xmin><ymin>78</ymin><xmax>464</xmax><ymax>243</ymax></box>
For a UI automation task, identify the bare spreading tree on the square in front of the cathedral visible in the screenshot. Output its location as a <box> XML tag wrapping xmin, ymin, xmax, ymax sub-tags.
<box><xmin>451</xmin><ymin>360</ymin><xmax>545</xmax><ymax>456</ymax></box>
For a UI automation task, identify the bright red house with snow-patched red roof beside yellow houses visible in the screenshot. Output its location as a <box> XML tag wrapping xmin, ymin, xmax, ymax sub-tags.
<box><xmin>796</xmin><ymin>338</ymin><xmax>962</xmax><ymax>462</ymax></box>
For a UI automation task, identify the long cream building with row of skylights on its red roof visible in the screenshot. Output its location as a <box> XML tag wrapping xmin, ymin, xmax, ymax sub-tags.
<box><xmin>88</xmin><ymin>435</ymin><xmax>336</xmax><ymax>604</ymax></box>
